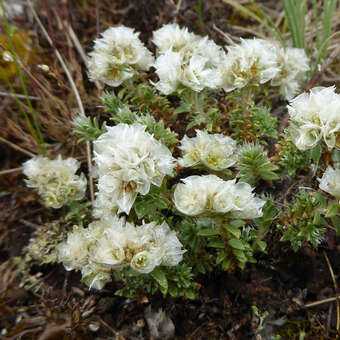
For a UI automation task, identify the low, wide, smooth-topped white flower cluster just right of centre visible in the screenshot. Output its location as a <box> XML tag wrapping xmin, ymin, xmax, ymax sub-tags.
<box><xmin>174</xmin><ymin>175</ymin><xmax>265</xmax><ymax>219</ymax></box>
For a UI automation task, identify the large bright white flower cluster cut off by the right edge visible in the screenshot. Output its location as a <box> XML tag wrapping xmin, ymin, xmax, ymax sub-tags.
<box><xmin>288</xmin><ymin>86</ymin><xmax>340</xmax><ymax>150</ymax></box>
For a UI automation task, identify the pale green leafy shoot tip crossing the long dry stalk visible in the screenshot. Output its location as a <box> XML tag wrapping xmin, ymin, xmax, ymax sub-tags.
<box><xmin>72</xmin><ymin>115</ymin><xmax>106</xmax><ymax>143</ymax></box>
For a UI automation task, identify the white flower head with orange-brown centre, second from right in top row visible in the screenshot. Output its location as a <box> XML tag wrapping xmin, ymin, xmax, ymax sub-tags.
<box><xmin>222</xmin><ymin>39</ymin><xmax>280</xmax><ymax>92</ymax></box>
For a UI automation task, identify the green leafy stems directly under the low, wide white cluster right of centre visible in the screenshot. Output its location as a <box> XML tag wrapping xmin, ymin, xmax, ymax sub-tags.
<box><xmin>178</xmin><ymin>215</ymin><xmax>266</xmax><ymax>274</ymax></box>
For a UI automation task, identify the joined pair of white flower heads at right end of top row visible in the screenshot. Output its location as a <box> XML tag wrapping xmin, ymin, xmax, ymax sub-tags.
<box><xmin>222</xmin><ymin>39</ymin><xmax>309</xmax><ymax>99</ymax></box>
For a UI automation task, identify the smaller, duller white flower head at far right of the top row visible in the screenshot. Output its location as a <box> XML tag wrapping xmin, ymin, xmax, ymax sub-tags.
<box><xmin>271</xmin><ymin>48</ymin><xmax>310</xmax><ymax>100</ymax></box>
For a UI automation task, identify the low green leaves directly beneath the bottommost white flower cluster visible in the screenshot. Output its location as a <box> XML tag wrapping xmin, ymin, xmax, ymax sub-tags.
<box><xmin>115</xmin><ymin>263</ymin><xmax>198</xmax><ymax>299</ymax></box>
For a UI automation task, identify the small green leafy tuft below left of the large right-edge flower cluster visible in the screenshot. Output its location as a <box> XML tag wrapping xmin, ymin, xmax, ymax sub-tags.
<box><xmin>275</xmin><ymin>133</ymin><xmax>312</xmax><ymax>178</ymax></box>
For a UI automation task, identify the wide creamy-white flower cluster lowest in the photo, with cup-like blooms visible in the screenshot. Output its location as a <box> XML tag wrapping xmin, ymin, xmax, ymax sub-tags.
<box><xmin>58</xmin><ymin>216</ymin><xmax>185</xmax><ymax>289</ymax></box>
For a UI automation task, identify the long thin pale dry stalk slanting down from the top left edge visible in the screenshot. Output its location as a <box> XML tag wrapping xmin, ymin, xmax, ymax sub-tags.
<box><xmin>27</xmin><ymin>0</ymin><xmax>94</xmax><ymax>202</ymax></box>
